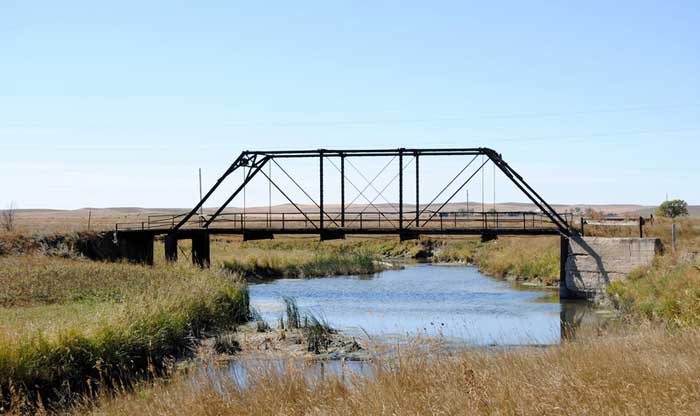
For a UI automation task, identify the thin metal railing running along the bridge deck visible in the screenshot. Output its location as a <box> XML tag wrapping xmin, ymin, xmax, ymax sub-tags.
<box><xmin>116</xmin><ymin>210</ymin><xmax>573</xmax><ymax>231</ymax></box>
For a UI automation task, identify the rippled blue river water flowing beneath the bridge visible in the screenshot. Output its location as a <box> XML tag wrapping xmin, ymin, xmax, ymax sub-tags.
<box><xmin>250</xmin><ymin>264</ymin><xmax>570</xmax><ymax>346</ymax></box>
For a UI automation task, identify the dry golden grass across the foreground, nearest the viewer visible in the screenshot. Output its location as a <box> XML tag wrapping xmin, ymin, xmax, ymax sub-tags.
<box><xmin>86</xmin><ymin>328</ymin><xmax>700</xmax><ymax>416</ymax></box>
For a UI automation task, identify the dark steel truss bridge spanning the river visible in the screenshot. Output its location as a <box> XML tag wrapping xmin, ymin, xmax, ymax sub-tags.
<box><xmin>115</xmin><ymin>147</ymin><xmax>576</xmax><ymax>264</ymax></box>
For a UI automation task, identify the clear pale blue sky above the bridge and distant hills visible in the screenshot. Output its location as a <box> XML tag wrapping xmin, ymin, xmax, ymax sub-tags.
<box><xmin>0</xmin><ymin>1</ymin><xmax>700</xmax><ymax>208</ymax></box>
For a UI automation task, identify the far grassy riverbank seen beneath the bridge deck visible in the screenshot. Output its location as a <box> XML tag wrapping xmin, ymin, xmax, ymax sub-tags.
<box><xmin>212</xmin><ymin>237</ymin><xmax>559</xmax><ymax>287</ymax></box>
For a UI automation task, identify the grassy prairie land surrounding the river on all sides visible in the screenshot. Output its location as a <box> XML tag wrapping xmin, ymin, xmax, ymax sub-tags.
<box><xmin>0</xmin><ymin>213</ymin><xmax>700</xmax><ymax>415</ymax></box>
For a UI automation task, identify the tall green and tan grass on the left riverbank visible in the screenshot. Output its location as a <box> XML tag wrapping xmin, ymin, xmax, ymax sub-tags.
<box><xmin>0</xmin><ymin>255</ymin><xmax>248</xmax><ymax>409</ymax></box>
